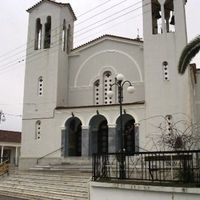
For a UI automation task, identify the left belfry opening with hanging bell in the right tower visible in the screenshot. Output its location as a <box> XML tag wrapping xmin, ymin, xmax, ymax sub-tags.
<box><xmin>151</xmin><ymin>0</ymin><xmax>163</xmax><ymax>34</ymax></box>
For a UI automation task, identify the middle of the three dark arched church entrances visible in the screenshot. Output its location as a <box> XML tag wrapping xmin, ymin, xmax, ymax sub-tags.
<box><xmin>89</xmin><ymin>114</ymin><xmax>108</xmax><ymax>155</ymax></box>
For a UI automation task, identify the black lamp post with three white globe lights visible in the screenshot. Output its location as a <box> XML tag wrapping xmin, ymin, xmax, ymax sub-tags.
<box><xmin>108</xmin><ymin>74</ymin><xmax>135</xmax><ymax>179</ymax></box>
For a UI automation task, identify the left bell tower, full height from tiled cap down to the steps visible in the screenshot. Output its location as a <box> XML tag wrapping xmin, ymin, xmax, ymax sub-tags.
<box><xmin>20</xmin><ymin>0</ymin><xmax>76</xmax><ymax>165</ymax></box>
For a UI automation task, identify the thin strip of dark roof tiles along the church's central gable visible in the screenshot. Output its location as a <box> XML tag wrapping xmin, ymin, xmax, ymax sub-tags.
<box><xmin>72</xmin><ymin>34</ymin><xmax>143</xmax><ymax>51</ymax></box>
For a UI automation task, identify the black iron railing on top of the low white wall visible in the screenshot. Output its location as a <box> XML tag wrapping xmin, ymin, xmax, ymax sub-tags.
<box><xmin>93</xmin><ymin>150</ymin><xmax>200</xmax><ymax>184</ymax></box>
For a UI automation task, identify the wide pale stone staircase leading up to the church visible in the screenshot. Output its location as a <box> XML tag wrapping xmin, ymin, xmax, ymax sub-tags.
<box><xmin>0</xmin><ymin>169</ymin><xmax>91</xmax><ymax>200</ymax></box>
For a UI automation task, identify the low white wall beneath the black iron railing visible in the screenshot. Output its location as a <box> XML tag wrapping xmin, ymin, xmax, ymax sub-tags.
<box><xmin>90</xmin><ymin>182</ymin><xmax>200</xmax><ymax>200</ymax></box>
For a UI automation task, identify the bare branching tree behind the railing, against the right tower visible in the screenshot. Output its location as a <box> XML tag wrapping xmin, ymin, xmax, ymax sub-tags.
<box><xmin>145</xmin><ymin>115</ymin><xmax>200</xmax><ymax>151</ymax></box>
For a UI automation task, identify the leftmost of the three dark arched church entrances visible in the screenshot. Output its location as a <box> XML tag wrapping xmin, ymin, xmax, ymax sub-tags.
<box><xmin>64</xmin><ymin>117</ymin><xmax>82</xmax><ymax>156</ymax></box>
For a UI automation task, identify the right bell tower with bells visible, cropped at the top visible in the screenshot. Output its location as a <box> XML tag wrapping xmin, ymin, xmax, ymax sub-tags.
<box><xmin>143</xmin><ymin>0</ymin><xmax>191</xmax><ymax>141</ymax></box>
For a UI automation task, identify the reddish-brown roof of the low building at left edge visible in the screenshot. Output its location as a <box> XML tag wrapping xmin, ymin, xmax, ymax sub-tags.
<box><xmin>0</xmin><ymin>130</ymin><xmax>21</xmax><ymax>143</ymax></box>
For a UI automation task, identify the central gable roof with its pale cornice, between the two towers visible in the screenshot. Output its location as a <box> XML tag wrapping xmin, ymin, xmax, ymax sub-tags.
<box><xmin>72</xmin><ymin>34</ymin><xmax>143</xmax><ymax>51</ymax></box>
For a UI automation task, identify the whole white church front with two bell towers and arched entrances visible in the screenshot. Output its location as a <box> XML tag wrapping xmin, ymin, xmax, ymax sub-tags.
<box><xmin>20</xmin><ymin>0</ymin><xmax>196</xmax><ymax>169</ymax></box>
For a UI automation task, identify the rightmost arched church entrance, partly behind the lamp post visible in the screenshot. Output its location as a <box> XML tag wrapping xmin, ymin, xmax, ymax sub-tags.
<box><xmin>116</xmin><ymin>114</ymin><xmax>135</xmax><ymax>153</ymax></box>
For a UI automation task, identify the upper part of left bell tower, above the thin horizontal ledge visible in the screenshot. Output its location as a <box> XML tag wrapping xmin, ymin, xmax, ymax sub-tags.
<box><xmin>24</xmin><ymin>0</ymin><xmax>76</xmax><ymax>118</ymax></box>
